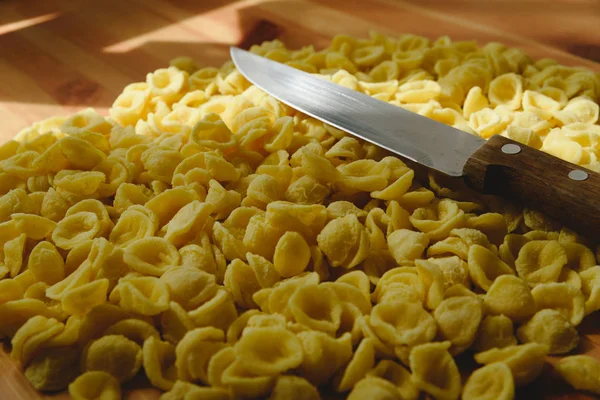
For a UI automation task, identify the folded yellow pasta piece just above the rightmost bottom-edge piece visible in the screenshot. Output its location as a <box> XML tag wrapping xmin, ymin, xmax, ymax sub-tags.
<box><xmin>475</xmin><ymin>343</ymin><xmax>548</xmax><ymax>386</ymax></box>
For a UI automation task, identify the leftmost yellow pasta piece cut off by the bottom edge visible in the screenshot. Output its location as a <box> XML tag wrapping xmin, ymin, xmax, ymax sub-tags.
<box><xmin>69</xmin><ymin>371</ymin><xmax>121</xmax><ymax>400</ymax></box>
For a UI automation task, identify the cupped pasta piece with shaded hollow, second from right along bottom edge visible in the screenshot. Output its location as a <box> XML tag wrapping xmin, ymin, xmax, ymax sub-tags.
<box><xmin>410</xmin><ymin>342</ymin><xmax>462</xmax><ymax>399</ymax></box>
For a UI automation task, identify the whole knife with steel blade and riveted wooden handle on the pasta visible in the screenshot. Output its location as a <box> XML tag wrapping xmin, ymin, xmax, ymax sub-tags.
<box><xmin>230</xmin><ymin>47</ymin><xmax>600</xmax><ymax>241</ymax></box>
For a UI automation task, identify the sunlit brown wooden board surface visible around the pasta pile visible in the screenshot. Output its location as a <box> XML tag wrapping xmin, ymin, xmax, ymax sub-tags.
<box><xmin>0</xmin><ymin>0</ymin><xmax>600</xmax><ymax>400</ymax></box>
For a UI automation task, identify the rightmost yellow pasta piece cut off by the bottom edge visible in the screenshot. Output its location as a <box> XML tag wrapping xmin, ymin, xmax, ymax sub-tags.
<box><xmin>462</xmin><ymin>362</ymin><xmax>515</xmax><ymax>400</ymax></box>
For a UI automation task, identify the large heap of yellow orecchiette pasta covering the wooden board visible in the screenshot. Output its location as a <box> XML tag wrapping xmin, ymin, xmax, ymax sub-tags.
<box><xmin>0</xmin><ymin>33</ymin><xmax>600</xmax><ymax>400</ymax></box>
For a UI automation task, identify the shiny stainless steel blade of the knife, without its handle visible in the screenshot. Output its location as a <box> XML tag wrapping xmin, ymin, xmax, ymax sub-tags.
<box><xmin>231</xmin><ymin>47</ymin><xmax>485</xmax><ymax>176</ymax></box>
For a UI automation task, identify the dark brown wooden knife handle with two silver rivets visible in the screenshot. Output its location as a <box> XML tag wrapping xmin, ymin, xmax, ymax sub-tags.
<box><xmin>464</xmin><ymin>135</ymin><xmax>600</xmax><ymax>242</ymax></box>
